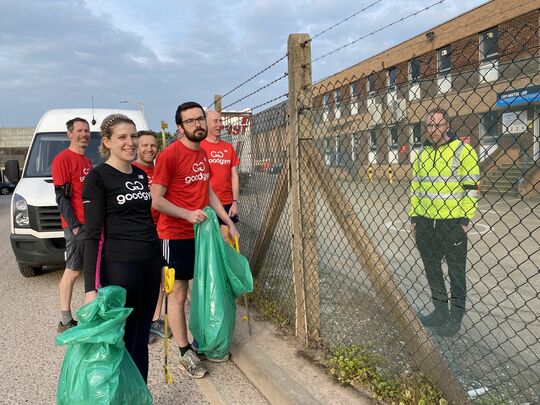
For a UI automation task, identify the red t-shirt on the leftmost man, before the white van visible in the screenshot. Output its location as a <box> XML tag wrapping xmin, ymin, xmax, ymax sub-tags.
<box><xmin>52</xmin><ymin>148</ymin><xmax>92</xmax><ymax>228</ymax></box>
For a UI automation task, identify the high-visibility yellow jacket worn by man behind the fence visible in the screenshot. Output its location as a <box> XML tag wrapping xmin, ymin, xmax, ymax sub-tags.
<box><xmin>409</xmin><ymin>134</ymin><xmax>480</xmax><ymax>224</ymax></box>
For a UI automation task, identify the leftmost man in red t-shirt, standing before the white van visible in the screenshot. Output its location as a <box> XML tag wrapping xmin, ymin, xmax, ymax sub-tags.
<box><xmin>52</xmin><ymin>117</ymin><xmax>92</xmax><ymax>333</ymax></box>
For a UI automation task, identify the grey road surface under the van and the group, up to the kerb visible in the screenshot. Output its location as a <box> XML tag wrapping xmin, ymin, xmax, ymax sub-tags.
<box><xmin>0</xmin><ymin>196</ymin><xmax>267</xmax><ymax>404</ymax></box>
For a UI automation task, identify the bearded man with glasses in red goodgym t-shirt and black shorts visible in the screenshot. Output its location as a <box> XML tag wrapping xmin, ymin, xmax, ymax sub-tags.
<box><xmin>152</xmin><ymin>102</ymin><xmax>238</xmax><ymax>378</ymax></box>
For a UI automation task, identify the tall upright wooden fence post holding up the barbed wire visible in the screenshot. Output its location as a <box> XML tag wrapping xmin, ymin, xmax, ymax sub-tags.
<box><xmin>287</xmin><ymin>34</ymin><xmax>320</xmax><ymax>344</ymax></box>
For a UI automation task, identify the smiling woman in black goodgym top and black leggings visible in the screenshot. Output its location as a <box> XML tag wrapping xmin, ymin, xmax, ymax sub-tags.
<box><xmin>82</xmin><ymin>114</ymin><xmax>163</xmax><ymax>381</ymax></box>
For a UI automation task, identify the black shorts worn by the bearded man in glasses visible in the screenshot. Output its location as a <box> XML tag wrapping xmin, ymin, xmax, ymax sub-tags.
<box><xmin>162</xmin><ymin>239</ymin><xmax>195</xmax><ymax>280</ymax></box>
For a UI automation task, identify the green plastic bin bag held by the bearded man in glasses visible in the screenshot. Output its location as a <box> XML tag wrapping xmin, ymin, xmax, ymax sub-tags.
<box><xmin>189</xmin><ymin>207</ymin><xmax>253</xmax><ymax>358</ymax></box>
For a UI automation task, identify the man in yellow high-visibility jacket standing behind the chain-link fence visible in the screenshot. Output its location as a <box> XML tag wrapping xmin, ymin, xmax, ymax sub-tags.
<box><xmin>409</xmin><ymin>108</ymin><xmax>480</xmax><ymax>336</ymax></box>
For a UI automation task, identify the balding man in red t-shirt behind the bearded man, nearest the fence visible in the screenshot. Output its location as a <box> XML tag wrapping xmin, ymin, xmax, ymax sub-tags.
<box><xmin>201</xmin><ymin>111</ymin><xmax>240</xmax><ymax>239</ymax></box>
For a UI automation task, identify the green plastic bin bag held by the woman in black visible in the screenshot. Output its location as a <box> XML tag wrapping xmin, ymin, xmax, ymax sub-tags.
<box><xmin>56</xmin><ymin>286</ymin><xmax>152</xmax><ymax>405</ymax></box>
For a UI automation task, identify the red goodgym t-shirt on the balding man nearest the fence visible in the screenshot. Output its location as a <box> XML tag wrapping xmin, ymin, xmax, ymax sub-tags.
<box><xmin>201</xmin><ymin>139</ymin><xmax>240</xmax><ymax>205</ymax></box>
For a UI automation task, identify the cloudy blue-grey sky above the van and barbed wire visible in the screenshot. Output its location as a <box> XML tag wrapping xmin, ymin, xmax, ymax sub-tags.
<box><xmin>0</xmin><ymin>0</ymin><xmax>485</xmax><ymax>130</ymax></box>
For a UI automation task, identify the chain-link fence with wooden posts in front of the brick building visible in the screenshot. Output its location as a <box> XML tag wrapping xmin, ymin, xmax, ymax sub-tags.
<box><xmin>220</xmin><ymin>10</ymin><xmax>540</xmax><ymax>404</ymax></box>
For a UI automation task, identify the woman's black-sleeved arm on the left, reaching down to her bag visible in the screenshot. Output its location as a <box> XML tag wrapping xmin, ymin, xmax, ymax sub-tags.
<box><xmin>82</xmin><ymin>171</ymin><xmax>106</xmax><ymax>296</ymax></box>
